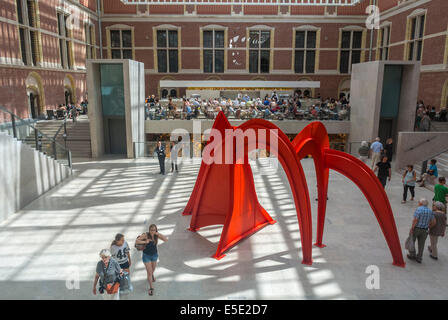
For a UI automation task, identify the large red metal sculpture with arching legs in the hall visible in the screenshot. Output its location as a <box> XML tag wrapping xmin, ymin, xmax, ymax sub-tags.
<box><xmin>183</xmin><ymin>112</ymin><xmax>405</xmax><ymax>267</ymax></box>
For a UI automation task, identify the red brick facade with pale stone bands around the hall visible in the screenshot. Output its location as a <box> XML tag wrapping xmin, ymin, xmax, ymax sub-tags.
<box><xmin>0</xmin><ymin>0</ymin><xmax>448</xmax><ymax>121</ymax></box>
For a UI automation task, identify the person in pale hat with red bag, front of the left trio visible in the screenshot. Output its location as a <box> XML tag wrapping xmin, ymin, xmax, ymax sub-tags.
<box><xmin>93</xmin><ymin>249</ymin><xmax>123</xmax><ymax>300</ymax></box>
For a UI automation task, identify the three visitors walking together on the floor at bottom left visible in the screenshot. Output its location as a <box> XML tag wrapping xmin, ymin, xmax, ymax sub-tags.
<box><xmin>93</xmin><ymin>224</ymin><xmax>168</xmax><ymax>300</ymax></box>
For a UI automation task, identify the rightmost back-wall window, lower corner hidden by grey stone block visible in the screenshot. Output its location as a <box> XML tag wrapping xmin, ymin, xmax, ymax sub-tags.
<box><xmin>339</xmin><ymin>31</ymin><xmax>362</xmax><ymax>73</ymax></box>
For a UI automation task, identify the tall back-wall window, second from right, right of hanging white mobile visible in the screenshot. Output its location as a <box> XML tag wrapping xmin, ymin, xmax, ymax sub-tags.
<box><xmin>294</xmin><ymin>30</ymin><xmax>317</xmax><ymax>73</ymax></box>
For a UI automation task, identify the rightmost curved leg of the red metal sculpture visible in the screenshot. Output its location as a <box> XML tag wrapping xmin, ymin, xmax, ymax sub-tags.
<box><xmin>325</xmin><ymin>149</ymin><xmax>405</xmax><ymax>267</ymax></box>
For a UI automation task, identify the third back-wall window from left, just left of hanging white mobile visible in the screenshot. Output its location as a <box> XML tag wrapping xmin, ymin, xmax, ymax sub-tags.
<box><xmin>202</xmin><ymin>30</ymin><xmax>224</xmax><ymax>73</ymax></box>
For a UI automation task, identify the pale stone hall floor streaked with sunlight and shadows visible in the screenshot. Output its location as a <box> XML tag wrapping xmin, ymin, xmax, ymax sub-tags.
<box><xmin>0</xmin><ymin>158</ymin><xmax>448</xmax><ymax>300</ymax></box>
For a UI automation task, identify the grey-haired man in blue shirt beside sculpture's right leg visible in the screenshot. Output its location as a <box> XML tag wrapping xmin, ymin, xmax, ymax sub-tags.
<box><xmin>407</xmin><ymin>198</ymin><xmax>436</xmax><ymax>263</ymax></box>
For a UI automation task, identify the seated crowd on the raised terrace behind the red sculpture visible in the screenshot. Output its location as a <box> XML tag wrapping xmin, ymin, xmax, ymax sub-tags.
<box><xmin>145</xmin><ymin>90</ymin><xmax>350</xmax><ymax>120</ymax></box>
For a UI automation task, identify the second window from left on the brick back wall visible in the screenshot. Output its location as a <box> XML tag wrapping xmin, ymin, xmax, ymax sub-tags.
<box><xmin>157</xmin><ymin>30</ymin><xmax>179</xmax><ymax>73</ymax></box>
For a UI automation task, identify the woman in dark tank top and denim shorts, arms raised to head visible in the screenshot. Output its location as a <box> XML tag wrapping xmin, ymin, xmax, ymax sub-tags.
<box><xmin>135</xmin><ymin>224</ymin><xmax>168</xmax><ymax>296</ymax></box>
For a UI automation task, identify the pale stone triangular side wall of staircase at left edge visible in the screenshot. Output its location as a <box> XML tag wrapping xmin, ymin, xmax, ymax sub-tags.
<box><xmin>0</xmin><ymin>132</ymin><xmax>71</xmax><ymax>223</ymax></box>
